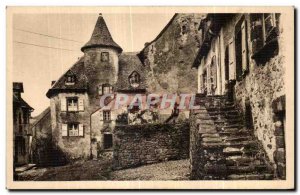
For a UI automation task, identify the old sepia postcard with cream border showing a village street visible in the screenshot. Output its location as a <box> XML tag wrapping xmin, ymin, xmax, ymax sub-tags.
<box><xmin>6</xmin><ymin>7</ymin><xmax>295</xmax><ymax>189</ymax></box>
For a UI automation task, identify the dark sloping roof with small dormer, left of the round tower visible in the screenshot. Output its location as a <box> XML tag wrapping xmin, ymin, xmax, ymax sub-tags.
<box><xmin>46</xmin><ymin>57</ymin><xmax>88</xmax><ymax>98</ymax></box>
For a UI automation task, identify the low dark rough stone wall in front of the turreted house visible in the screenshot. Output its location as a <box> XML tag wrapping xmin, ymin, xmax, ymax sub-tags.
<box><xmin>113</xmin><ymin>122</ymin><xmax>189</xmax><ymax>169</ymax></box>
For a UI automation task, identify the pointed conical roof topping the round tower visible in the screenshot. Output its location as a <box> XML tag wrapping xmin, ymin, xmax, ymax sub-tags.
<box><xmin>81</xmin><ymin>14</ymin><xmax>122</xmax><ymax>53</ymax></box>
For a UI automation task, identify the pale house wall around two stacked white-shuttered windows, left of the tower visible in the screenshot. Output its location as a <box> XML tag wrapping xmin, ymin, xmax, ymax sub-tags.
<box><xmin>50</xmin><ymin>93</ymin><xmax>90</xmax><ymax>159</ymax></box>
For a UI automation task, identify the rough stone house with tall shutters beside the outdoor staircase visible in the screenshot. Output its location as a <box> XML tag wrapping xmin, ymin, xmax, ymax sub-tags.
<box><xmin>193</xmin><ymin>13</ymin><xmax>286</xmax><ymax>177</ymax></box>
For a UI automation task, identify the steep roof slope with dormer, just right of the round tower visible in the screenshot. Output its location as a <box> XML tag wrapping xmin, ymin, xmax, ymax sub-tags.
<box><xmin>116</xmin><ymin>52</ymin><xmax>147</xmax><ymax>92</ymax></box>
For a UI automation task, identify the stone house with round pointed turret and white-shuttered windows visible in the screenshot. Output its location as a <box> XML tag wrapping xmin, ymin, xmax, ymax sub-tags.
<box><xmin>46</xmin><ymin>14</ymin><xmax>180</xmax><ymax>159</ymax></box>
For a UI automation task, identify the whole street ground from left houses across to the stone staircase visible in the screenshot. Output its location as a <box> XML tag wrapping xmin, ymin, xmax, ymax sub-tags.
<box><xmin>18</xmin><ymin>160</ymin><xmax>189</xmax><ymax>181</ymax></box>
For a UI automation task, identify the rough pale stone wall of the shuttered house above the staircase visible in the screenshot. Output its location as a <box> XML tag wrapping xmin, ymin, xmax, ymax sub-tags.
<box><xmin>198</xmin><ymin>14</ymin><xmax>285</xmax><ymax>165</ymax></box>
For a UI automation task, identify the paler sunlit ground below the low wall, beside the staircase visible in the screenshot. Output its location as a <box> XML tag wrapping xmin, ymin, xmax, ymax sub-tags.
<box><xmin>110</xmin><ymin>159</ymin><xmax>189</xmax><ymax>180</ymax></box>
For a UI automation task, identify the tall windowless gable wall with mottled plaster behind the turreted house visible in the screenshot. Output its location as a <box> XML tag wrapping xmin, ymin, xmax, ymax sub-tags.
<box><xmin>141</xmin><ymin>14</ymin><xmax>202</xmax><ymax>93</ymax></box>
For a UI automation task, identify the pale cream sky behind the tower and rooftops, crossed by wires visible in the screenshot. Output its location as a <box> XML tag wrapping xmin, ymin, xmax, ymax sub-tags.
<box><xmin>12</xmin><ymin>13</ymin><xmax>174</xmax><ymax>116</ymax></box>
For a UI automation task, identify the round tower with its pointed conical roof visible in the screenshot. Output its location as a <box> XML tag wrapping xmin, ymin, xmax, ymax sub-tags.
<box><xmin>81</xmin><ymin>14</ymin><xmax>122</xmax><ymax>102</ymax></box>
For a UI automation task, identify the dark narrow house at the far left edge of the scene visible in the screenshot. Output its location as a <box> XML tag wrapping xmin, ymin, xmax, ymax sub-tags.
<box><xmin>13</xmin><ymin>82</ymin><xmax>33</xmax><ymax>166</ymax></box>
